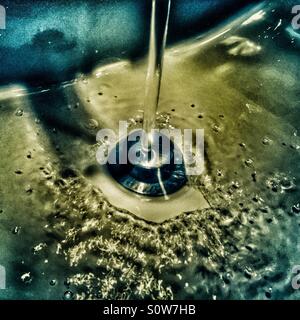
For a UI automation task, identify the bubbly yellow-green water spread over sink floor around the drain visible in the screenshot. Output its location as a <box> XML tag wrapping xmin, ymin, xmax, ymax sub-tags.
<box><xmin>0</xmin><ymin>3</ymin><xmax>300</xmax><ymax>299</ymax></box>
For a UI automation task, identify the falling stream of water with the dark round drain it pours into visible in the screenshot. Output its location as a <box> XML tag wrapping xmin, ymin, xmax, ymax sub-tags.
<box><xmin>107</xmin><ymin>0</ymin><xmax>187</xmax><ymax>199</ymax></box>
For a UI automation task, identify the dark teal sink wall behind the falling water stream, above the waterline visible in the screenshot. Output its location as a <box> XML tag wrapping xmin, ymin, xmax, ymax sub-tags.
<box><xmin>0</xmin><ymin>0</ymin><xmax>261</xmax><ymax>84</ymax></box>
